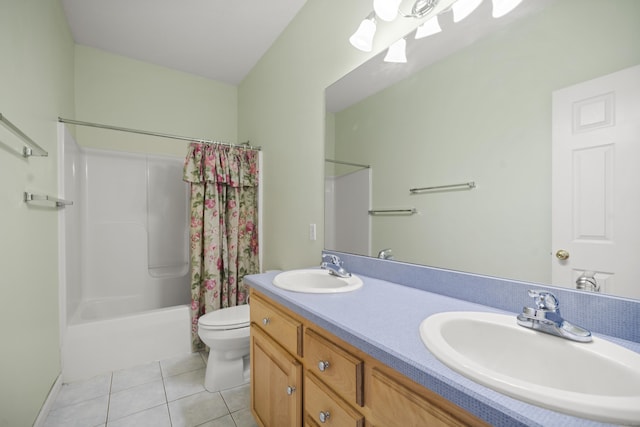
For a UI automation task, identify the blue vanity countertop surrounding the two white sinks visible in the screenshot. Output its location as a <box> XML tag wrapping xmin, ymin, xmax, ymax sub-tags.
<box><xmin>244</xmin><ymin>271</ymin><xmax>640</xmax><ymax>427</ymax></box>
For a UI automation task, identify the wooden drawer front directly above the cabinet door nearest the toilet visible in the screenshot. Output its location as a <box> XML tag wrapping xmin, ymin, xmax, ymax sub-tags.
<box><xmin>249</xmin><ymin>293</ymin><xmax>302</xmax><ymax>356</ymax></box>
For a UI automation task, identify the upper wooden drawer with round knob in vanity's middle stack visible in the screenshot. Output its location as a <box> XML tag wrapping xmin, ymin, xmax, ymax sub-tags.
<box><xmin>304</xmin><ymin>328</ymin><xmax>364</xmax><ymax>406</ymax></box>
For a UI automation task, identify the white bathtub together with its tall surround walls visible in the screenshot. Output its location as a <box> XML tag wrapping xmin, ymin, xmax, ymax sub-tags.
<box><xmin>58</xmin><ymin>124</ymin><xmax>191</xmax><ymax>382</ymax></box>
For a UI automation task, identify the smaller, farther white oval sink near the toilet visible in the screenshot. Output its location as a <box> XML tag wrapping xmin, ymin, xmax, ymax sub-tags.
<box><xmin>273</xmin><ymin>269</ymin><xmax>362</xmax><ymax>294</ymax></box>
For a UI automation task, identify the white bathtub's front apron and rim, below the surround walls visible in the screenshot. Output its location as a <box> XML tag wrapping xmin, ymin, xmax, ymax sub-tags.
<box><xmin>62</xmin><ymin>299</ymin><xmax>191</xmax><ymax>382</ymax></box>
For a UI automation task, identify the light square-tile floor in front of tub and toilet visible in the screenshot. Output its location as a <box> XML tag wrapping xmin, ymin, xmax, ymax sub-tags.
<box><xmin>44</xmin><ymin>353</ymin><xmax>257</xmax><ymax>427</ymax></box>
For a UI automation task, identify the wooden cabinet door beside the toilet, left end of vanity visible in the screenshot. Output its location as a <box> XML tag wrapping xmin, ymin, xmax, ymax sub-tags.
<box><xmin>251</xmin><ymin>325</ymin><xmax>302</xmax><ymax>427</ymax></box>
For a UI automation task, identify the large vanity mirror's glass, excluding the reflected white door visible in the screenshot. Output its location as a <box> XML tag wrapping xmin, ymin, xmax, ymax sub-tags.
<box><xmin>325</xmin><ymin>0</ymin><xmax>640</xmax><ymax>298</ymax></box>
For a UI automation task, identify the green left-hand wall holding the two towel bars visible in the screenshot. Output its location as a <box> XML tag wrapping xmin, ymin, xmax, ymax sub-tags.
<box><xmin>0</xmin><ymin>0</ymin><xmax>74</xmax><ymax>427</ymax></box>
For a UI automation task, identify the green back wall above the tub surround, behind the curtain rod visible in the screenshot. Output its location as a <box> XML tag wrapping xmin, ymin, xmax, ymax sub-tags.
<box><xmin>75</xmin><ymin>45</ymin><xmax>238</xmax><ymax>156</ymax></box>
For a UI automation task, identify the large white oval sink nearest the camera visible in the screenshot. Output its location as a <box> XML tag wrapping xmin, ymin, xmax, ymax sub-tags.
<box><xmin>420</xmin><ymin>312</ymin><xmax>640</xmax><ymax>425</ymax></box>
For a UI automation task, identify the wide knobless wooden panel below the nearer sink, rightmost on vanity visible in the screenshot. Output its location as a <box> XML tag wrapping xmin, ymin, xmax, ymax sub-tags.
<box><xmin>368</xmin><ymin>368</ymin><xmax>486</xmax><ymax>427</ymax></box>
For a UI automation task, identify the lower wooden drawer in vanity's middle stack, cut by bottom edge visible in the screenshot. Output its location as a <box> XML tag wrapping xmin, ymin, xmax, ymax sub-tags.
<box><xmin>303</xmin><ymin>371</ymin><xmax>364</xmax><ymax>427</ymax></box>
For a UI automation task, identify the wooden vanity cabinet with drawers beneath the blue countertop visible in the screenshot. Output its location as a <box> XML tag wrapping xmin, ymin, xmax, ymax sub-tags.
<box><xmin>251</xmin><ymin>289</ymin><xmax>488</xmax><ymax>427</ymax></box>
